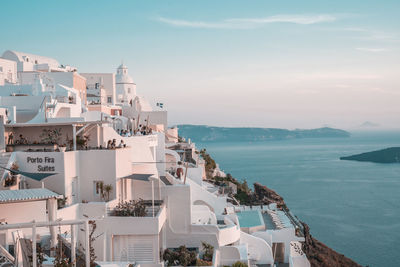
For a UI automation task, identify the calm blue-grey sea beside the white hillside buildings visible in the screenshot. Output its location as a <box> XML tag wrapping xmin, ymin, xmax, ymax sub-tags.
<box><xmin>197</xmin><ymin>132</ymin><xmax>400</xmax><ymax>267</ymax></box>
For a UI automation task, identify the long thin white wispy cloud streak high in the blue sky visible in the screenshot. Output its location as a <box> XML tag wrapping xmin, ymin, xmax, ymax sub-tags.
<box><xmin>157</xmin><ymin>14</ymin><xmax>337</xmax><ymax>29</ymax></box>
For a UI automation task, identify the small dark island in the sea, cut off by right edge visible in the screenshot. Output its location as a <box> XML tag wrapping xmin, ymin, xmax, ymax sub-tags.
<box><xmin>340</xmin><ymin>147</ymin><xmax>400</xmax><ymax>163</ymax></box>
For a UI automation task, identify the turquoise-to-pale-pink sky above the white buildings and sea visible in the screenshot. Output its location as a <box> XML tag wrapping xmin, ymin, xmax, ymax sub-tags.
<box><xmin>0</xmin><ymin>0</ymin><xmax>400</xmax><ymax>129</ymax></box>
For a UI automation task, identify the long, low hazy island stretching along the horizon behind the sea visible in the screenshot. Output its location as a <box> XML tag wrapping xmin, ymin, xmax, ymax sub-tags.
<box><xmin>178</xmin><ymin>124</ymin><xmax>350</xmax><ymax>142</ymax></box>
